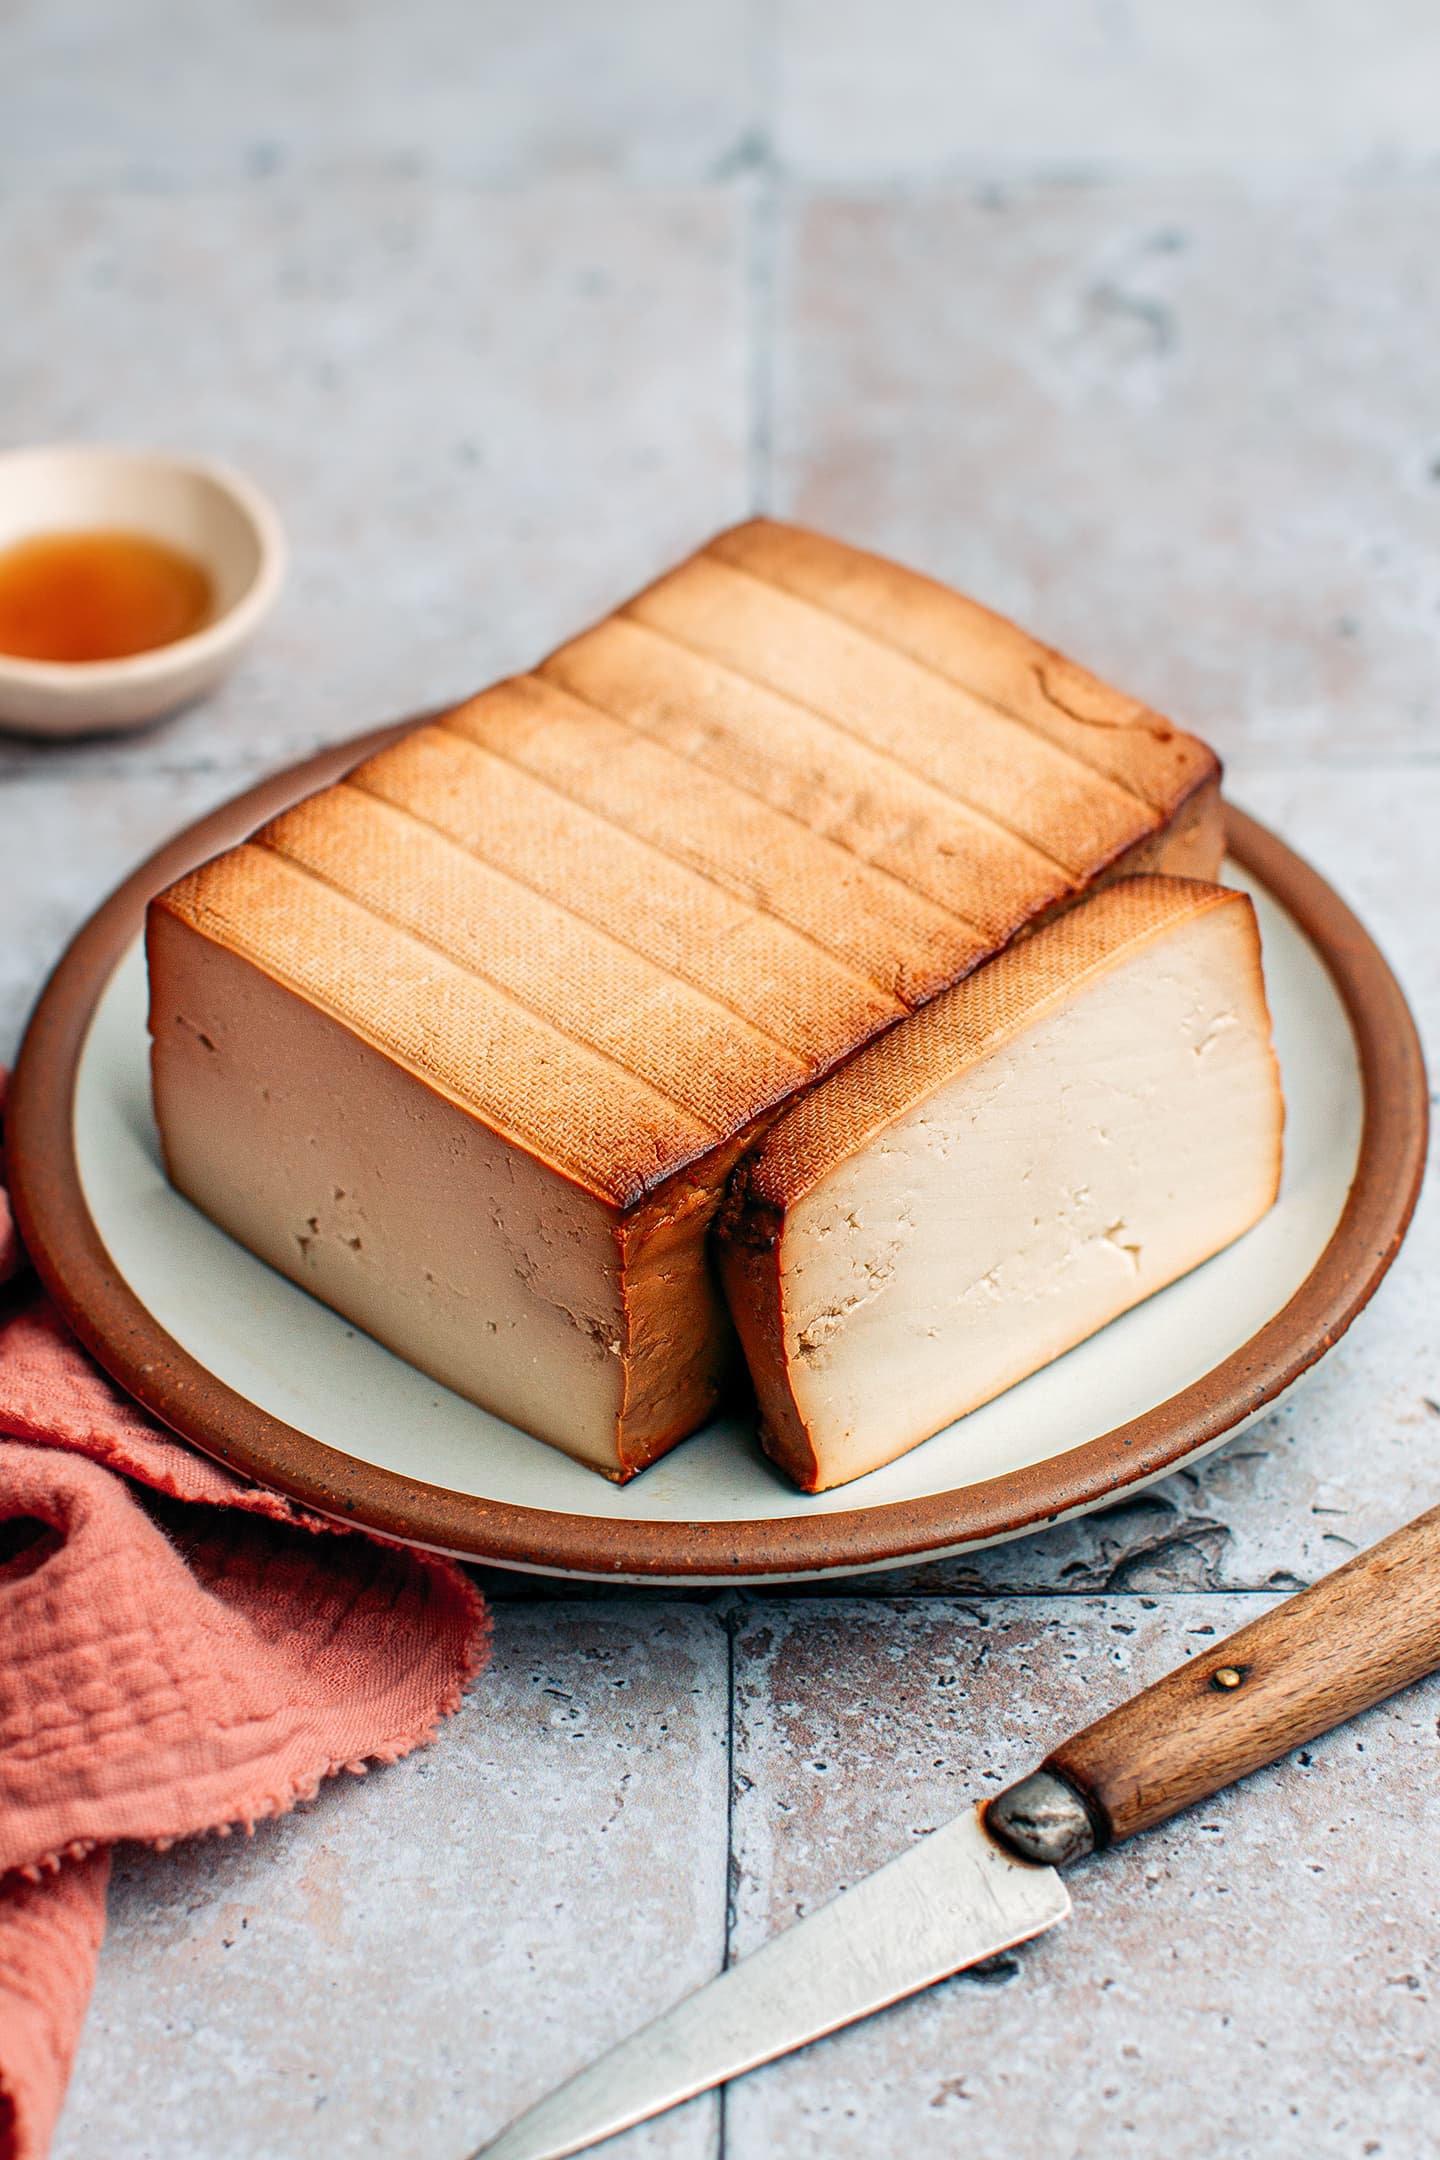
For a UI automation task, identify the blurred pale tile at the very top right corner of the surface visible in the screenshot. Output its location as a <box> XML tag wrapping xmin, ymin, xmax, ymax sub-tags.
<box><xmin>775</xmin><ymin>0</ymin><xmax>1440</xmax><ymax>184</ymax></box>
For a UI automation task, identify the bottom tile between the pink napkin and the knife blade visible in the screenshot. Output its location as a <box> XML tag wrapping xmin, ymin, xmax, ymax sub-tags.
<box><xmin>56</xmin><ymin>1603</ymin><xmax>728</xmax><ymax>2160</ymax></box>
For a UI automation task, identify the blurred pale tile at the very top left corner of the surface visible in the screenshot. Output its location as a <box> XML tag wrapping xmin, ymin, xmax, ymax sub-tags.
<box><xmin>0</xmin><ymin>0</ymin><xmax>751</xmax><ymax>188</ymax></box>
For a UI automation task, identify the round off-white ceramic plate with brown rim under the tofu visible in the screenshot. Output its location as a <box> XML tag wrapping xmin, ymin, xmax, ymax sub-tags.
<box><xmin>9</xmin><ymin>730</ymin><xmax>1425</xmax><ymax>1583</ymax></box>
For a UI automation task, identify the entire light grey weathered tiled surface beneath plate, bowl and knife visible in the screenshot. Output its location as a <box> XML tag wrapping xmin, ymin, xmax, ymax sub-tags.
<box><xmin>0</xmin><ymin>0</ymin><xmax>1440</xmax><ymax>2160</ymax></box>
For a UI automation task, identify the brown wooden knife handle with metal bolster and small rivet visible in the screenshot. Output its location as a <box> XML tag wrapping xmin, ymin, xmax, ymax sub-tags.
<box><xmin>987</xmin><ymin>1508</ymin><xmax>1440</xmax><ymax>1862</ymax></box>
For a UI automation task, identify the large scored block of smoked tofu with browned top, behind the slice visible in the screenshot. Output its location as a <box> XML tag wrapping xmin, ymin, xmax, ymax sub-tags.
<box><xmin>149</xmin><ymin>521</ymin><xmax>1222</xmax><ymax>1477</ymax></box>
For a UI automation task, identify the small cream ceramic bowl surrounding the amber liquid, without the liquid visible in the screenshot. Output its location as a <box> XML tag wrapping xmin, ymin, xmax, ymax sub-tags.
<box><xmin>0</xmin><ymin>443</ymin><xmax>285</xmax><ymax>734</ymax></box>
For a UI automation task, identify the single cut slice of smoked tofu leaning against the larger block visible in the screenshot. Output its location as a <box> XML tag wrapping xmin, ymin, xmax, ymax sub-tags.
<box><xmin>719</xmin><ymin>877</ymin><xmax>1285</xmax><ymax>1493</ymax></box>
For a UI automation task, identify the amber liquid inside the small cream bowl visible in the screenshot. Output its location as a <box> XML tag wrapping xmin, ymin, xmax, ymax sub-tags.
<box><xmin>0</xmin><ymin>531</ymin><xmax>214</xmax><ymax>661</ymax></box>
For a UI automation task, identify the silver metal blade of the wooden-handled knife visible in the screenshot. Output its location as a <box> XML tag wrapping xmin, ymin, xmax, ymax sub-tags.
<box><xmin>471</xmin><ymin>1808</ymin><xmax>1071</xmax><ymax>2160</ymax></box>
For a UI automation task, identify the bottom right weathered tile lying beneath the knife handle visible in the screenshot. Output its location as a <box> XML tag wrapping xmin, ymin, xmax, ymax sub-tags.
<box><xmin>725</xmin><ymin>1596</ymin><xmax>1440</xmax><ymax>2160</ymax></box>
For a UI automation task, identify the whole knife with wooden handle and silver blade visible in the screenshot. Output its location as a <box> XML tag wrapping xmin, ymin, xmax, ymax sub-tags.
<box><xmin>471</xmin><ymin>1508</ymin><xmax>1440</xmax><ymax>2160</ymax></box>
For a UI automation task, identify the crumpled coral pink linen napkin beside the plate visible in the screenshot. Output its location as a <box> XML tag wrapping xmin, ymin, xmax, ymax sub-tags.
<box><xmin>0</xmin><ymin>1076</ymin><xmax>488</xmax><ymax>2160</ymax></box>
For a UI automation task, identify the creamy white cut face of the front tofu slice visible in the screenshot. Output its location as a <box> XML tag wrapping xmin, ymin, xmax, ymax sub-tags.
<box><xmin>779</xmin><ymin>907</ymin><xmax>1282</xmax><ymax>1488</ymax></box>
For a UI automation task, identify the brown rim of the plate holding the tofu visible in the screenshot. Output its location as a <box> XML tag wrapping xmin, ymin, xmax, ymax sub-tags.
<box><xmin>6</xmin><ymin>719</ymin><xmax>1429</xmax><ymax>1581</ymax></box>
